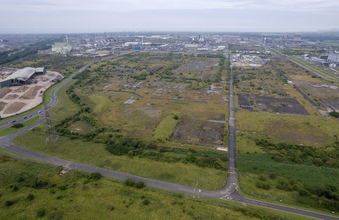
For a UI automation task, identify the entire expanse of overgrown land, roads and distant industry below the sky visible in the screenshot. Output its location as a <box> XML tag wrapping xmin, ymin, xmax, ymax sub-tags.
<box><xmin>0</xmin><ymin>32</ymin><xmax>339</xmax><ymax>219</ymax></box>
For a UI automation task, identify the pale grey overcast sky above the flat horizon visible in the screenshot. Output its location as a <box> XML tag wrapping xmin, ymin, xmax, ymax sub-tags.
<box><xmin>0</xmin><ymin>0</ymin><xmax>339</xmax><ymax>33</ymax></box>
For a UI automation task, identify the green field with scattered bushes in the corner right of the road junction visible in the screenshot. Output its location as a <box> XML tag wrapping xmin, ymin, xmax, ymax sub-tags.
<box><xmin>238</xmin><ymin>153</ymin><xmax>339</xmax><ymax>214</ymax></box>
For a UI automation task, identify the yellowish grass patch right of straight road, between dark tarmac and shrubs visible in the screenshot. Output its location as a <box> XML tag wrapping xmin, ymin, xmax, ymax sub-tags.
<box><xmin>235</xmin><ymin>111</ymin><xmax>339</xmax><ymax>146</ymax></box>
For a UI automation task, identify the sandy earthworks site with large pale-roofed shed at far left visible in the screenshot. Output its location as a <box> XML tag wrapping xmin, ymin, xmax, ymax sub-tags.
<box><xmin>0</xmin><ymin>67</ymin><xmax>63</xmax><ymax>118</ymax></box>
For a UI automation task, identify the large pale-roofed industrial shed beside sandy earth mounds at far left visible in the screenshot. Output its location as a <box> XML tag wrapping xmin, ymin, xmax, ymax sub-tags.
<box><xmin>0</xmin><ymin>67</ymin><xmax>46</xmax><ymax>88</ymax></box>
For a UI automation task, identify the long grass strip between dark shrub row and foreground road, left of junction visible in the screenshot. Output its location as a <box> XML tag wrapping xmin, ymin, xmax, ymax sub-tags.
<box><xmin>14</xmin><ymin>131</ymin><xmax>226</xmax><ymax>190</ymax></box>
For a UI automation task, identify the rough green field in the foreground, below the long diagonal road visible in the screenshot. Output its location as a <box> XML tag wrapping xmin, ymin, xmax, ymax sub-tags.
<box><xmin>0</xmin><ymin>156</ymin><xmax>306</xmax><ymax>220</ymax></box>
